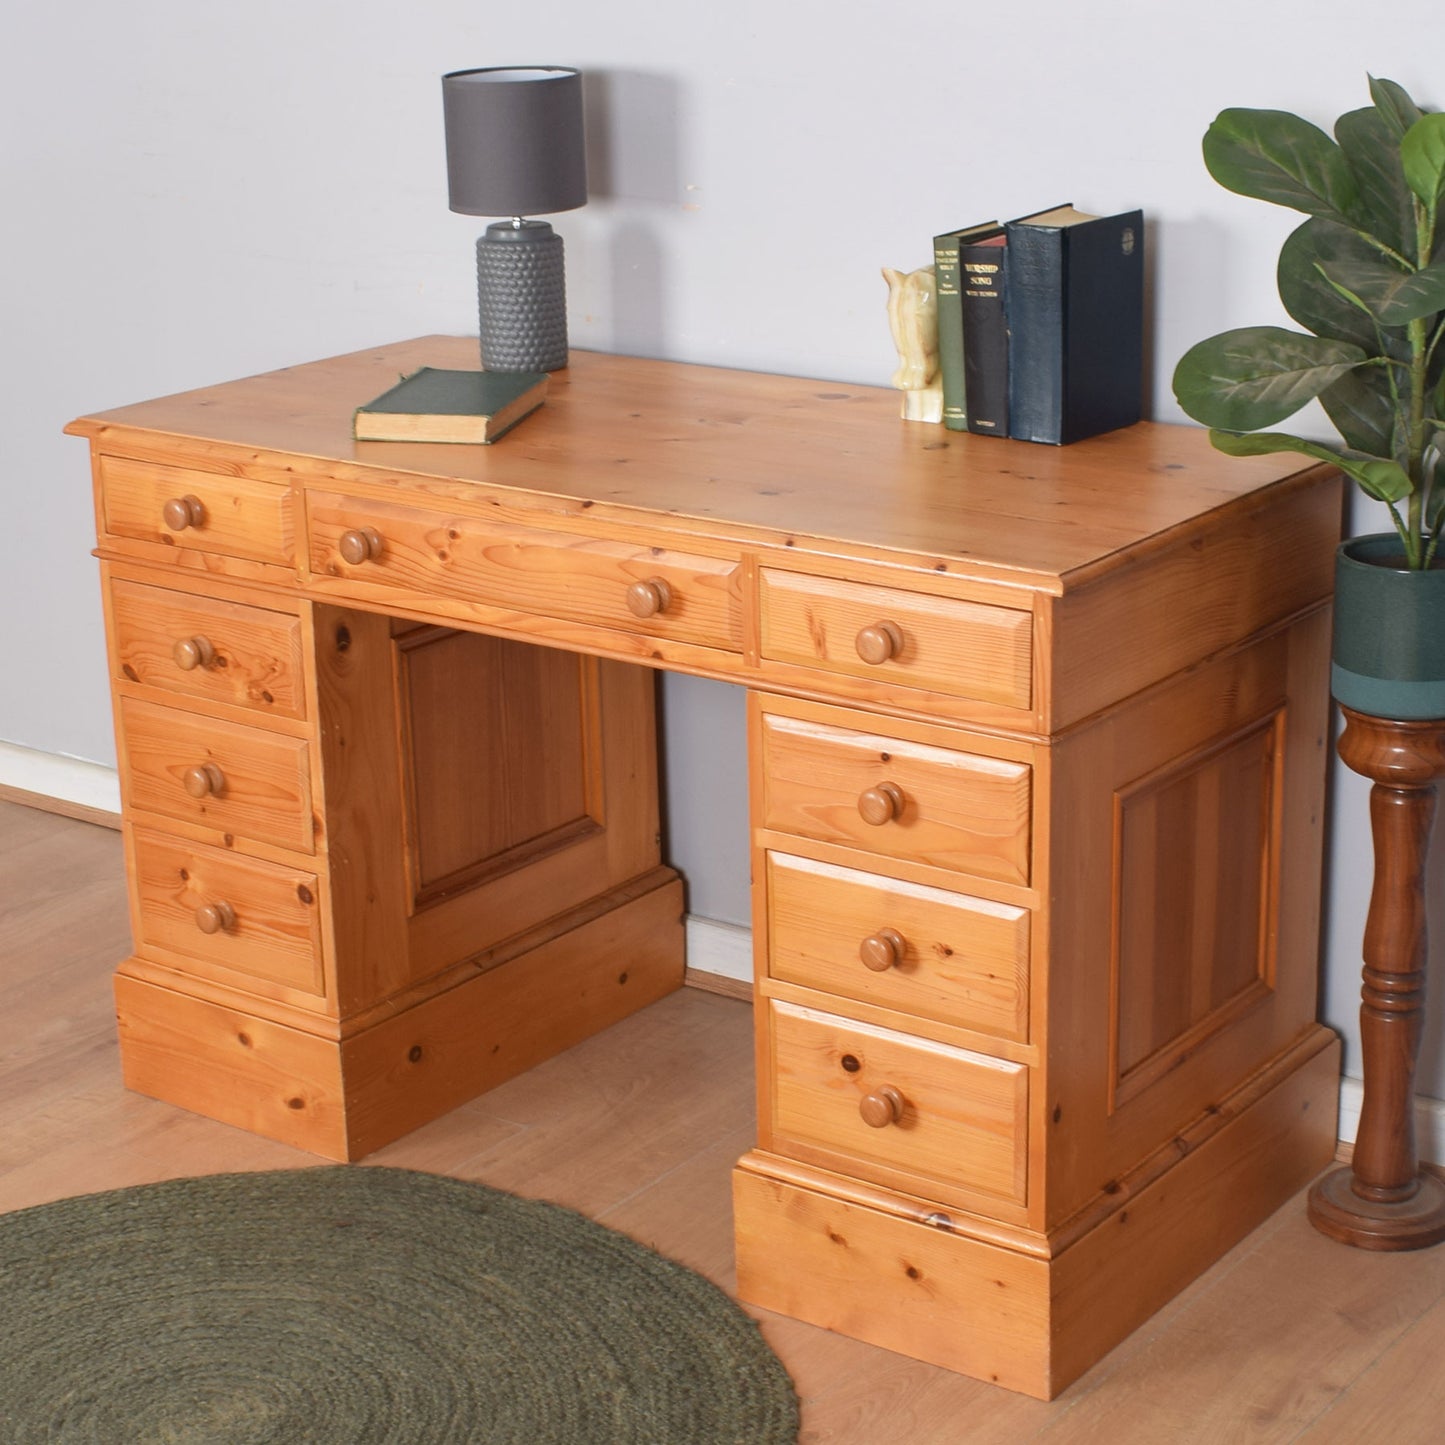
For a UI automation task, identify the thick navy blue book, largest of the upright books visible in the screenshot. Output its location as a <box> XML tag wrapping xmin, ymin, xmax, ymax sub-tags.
<box><xmin>1004</xmin><ymin>205</ymin><xmax>1144</xmax><ymax>445</ymax></box>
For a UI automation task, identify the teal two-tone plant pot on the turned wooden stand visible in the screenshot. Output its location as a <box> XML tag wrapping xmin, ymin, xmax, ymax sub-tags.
<box><xmin>1329</xmin><ymin>532</ymin><xmax>1445</xmax><ymax>721</ymax></box>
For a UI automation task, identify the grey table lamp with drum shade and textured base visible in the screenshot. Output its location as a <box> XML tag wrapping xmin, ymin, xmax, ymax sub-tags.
<box><xmin>442</xmin><ymin>65</ymin><xmax>587</xmax><ymax>371</ymax></box>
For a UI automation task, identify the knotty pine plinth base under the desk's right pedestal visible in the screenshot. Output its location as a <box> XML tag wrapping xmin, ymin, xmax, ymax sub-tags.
<box><xmin>733</xmin><ymin>1030</ymin><xmax>1340</xmax><ymax>1400</ymax></box>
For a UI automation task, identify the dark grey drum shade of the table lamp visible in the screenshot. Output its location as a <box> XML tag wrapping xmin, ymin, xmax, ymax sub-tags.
<box><xmin>442</xmin><ymin>65</ymin><xmax>587</xmax><ymax>215</ymax></box>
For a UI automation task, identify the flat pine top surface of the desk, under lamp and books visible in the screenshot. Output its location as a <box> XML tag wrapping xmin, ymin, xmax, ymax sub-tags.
<box><xmin>68</xmin><ymin>337</ymin><xmax>1321</xmax><ymax>590</ymax></box>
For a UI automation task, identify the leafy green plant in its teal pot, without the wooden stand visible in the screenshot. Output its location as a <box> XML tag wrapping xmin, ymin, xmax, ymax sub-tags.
<box><xmin>1173</xmin><ymin>78</ymin><xmax>1445</xmax><ymax>720</ymax></box>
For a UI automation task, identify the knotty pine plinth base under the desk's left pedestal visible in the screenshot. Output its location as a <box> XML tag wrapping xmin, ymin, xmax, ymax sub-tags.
<box><xmin>116</xmin><ymin>870</ymin><xmax>683</xmax><ymax>1160</ymax></box>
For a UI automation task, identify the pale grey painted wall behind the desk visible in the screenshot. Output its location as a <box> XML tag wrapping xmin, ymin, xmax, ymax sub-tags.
<box><xmin>0</xmin><ymin>0</ymin><xmax>1445</xmax><ymax>1095</ymax></box>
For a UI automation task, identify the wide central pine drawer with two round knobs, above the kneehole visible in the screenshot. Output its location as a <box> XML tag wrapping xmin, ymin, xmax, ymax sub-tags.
<box><xmin>308</xmin><ymin>493</ymin><xmax>743</xmax><ymax>650</ymax></box>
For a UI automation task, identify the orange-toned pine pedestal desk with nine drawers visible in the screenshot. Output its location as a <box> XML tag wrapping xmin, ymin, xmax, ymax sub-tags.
<box><xmin>69</xmin><ymin>337</ymin><xmax>1341</xmax><ymax>1397</ymax></box>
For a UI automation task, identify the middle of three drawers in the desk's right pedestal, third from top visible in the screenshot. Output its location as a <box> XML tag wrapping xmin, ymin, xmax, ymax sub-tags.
<box><xmin>767</xmin><ymin>853</ymin><xmax>1029</xmax><ymax>1043</ymax></box>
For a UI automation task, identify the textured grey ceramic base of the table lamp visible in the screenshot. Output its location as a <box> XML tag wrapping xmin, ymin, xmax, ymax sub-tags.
<box><xmin>477</xmin><ymin>221</ymin><xmax>566</xmax><ymax>371</ymax></box>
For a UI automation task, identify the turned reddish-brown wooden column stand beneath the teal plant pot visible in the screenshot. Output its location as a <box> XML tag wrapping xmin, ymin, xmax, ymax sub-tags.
<box><xmin>1309</xmin><ymin>708</ymin><xmax>1445</xmax><ymax>1250</ymax></box>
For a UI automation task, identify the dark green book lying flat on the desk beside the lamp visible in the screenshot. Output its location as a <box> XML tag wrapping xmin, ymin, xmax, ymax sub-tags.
<box><xmin>351</xmin><ymin>366</ymin><xmax>548</xmax><ymax>442</ymax></box>
